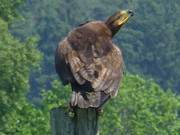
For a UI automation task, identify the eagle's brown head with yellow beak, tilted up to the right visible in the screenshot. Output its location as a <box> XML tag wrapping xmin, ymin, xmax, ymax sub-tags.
<box><xmin>105</xmin><ymin>10</ymin><xmax>134</xmax><ymax>36</ymax></box>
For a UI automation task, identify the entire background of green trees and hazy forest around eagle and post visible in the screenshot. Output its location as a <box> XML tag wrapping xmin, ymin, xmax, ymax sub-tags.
<box><xmin>0</xmin><ymin>0</ymin><xmax>180</xmax><ymax>135</ymax></box>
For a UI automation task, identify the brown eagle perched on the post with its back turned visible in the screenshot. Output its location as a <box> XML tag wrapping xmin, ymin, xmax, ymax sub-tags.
<box><xmin>55</xmin><ymin>10</ymin><xmax>133</xmax><ymax>108</ymax></box>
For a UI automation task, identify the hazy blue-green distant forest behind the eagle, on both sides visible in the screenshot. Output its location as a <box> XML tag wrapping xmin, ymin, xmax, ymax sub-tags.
<box><xmin>12</xmin><ymin>0</ymin><xmax>180</xmax><ymax>92</ymax></box>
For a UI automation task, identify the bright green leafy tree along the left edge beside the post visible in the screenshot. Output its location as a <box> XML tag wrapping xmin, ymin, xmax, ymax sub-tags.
<box><xmin>0</xmin><ymin>19</ymin><xmax>50</xmax><ymax>135</ymax></box>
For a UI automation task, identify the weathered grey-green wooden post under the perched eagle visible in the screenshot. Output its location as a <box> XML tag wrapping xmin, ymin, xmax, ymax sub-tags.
<box><xmin>51</xmin><ymin>108</ymin><xmax>98</xmax><ymax>135</ymax></box>
